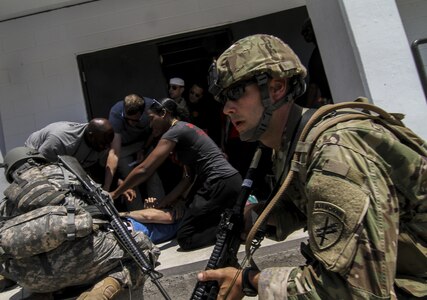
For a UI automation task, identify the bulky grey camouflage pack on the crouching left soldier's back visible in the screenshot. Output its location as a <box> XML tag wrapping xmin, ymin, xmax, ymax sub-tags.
<box><xmin>0</xmin><ymin>159</ymin><xmax>93</xmax><ymax>259</ymax></box>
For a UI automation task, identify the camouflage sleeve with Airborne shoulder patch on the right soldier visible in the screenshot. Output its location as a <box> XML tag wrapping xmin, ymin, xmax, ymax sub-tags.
<box><xmin>259</xmin><ymin>121</ymin><xmax>406</xmax><ymax>299</ymax></box>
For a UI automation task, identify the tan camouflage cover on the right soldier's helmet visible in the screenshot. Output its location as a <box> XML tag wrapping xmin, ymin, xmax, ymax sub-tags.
<box><xmin>209</xmin><ymin>34</ymin><xmax>307</xmax><ymax>96</ymax></box>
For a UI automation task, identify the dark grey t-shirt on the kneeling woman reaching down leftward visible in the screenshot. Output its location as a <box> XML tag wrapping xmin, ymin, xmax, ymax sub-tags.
<box><xmin>162</xmin><ymin>121</ymin><xmax>237</xmax><ymax>180</ymax></box>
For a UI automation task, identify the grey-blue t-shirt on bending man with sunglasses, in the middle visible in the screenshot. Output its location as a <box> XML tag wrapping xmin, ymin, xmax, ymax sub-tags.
<box><xmin>108</xmin><ymin>97</ymin><xmax>153</xmax><ymax>146</ymax></box>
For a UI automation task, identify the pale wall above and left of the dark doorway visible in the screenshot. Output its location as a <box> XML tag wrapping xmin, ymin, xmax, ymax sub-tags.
<box><xmin>0</xmin><ymin>0</ymin><xmax>305</xmax><ymax>150</ymax></box>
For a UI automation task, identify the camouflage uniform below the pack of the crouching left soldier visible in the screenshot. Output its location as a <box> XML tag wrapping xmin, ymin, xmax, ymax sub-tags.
<box><xmin>0</xmin><ymin>231</ymin><xmax>160</xmax><ymax>293</ymax></box>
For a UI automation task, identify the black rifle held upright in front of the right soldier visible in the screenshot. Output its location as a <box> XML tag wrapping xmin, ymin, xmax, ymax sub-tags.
<box><xmin>191</xmin><ymin>147</ymin><xmax>262</xmax><ymax>300</ymax></box>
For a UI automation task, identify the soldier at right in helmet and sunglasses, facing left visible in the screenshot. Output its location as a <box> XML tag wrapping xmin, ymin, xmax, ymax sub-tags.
<box><xmin>198</xmin><ymin>35</ymin><xmax>427</xmax><ymax>299</ymax></box>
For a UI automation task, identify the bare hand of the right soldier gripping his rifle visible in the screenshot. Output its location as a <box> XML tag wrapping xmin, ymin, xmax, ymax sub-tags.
<box><xmin>197</xmin><ymin>267</ymin><xmax>244</xmax><ymax>300</ymax></box>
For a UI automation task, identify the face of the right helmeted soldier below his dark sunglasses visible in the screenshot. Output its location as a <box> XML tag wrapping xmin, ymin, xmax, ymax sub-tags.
<box><xmin>223</xmin><ymin>83</ymin><xmax>264</xmax><ymax>135</ymax></box>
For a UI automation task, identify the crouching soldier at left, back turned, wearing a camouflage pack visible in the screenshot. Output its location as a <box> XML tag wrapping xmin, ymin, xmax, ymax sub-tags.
<box><xmin>0</xmin><ymin>147</ymin><xmax>160</xmax><ymax>300</ymax></box>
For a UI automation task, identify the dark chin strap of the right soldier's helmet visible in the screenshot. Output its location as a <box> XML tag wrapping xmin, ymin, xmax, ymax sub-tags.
<box><xmin>240</xmin><ymin>74</ymin><xmax>294</xmax><ymax>142</ymax></box>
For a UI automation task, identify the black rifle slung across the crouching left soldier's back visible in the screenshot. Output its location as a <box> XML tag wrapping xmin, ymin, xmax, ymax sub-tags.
<box><xmin>58</xmin><ymin>155</ymin><xmax>171</xmax><ymax>300</ymax></box>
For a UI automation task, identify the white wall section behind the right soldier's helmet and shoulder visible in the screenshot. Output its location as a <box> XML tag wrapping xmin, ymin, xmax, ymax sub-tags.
<box><xmin>307</xmin><ymin>0</ymin><xmax>427</xmax><ymax>139</ymax></box>
